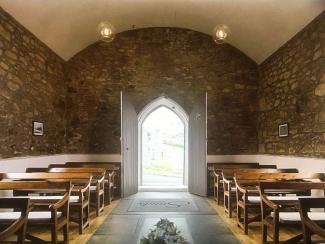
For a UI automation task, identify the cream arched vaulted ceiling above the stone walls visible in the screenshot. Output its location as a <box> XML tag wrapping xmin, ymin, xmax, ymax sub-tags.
<box><xmin>0</xmin><ymin>0</ymin><xmax>325</xmax><ymax>63</ymax></box>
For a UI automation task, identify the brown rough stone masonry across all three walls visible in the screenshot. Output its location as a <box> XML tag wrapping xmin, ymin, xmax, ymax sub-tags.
<box><xmin>0</xmin><ymin>8</ymin><xmax>325</xmax><ymax>158</ymax></box>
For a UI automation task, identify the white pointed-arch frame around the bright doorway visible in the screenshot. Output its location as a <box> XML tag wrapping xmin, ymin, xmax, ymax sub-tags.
<box><xmin>138</xmin><ymin>96</ymin><xmax>189</xmax><ymax>186</ymax></box>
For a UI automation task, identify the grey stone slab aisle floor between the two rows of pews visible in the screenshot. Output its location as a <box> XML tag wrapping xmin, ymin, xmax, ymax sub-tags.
<box><xmin>88</xmin><ymin>193</ymin><xmax>240</xmax><ymax>244</ymax></box>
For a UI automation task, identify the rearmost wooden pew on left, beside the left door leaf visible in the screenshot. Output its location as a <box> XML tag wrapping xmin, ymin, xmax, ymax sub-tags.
<box><xmin>65</xmin><ymin>162</ymin><xmax>121</xmax><ymax>204</ymax></box>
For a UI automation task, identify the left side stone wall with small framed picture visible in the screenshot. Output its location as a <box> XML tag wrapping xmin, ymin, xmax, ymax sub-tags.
<box><xmin>0</xmin><ymin>8</ymin><xmax>65</xmax><ymax>158</ymax></box>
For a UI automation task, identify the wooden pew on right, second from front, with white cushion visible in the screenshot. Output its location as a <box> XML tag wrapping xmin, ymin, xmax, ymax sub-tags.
<box><xmin>259</xmin><ymin>177</ymin><xmax>325</xmax><ymax>243</ymax></box>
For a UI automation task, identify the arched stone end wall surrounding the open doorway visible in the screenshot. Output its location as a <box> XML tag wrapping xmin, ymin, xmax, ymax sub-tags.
<box><xmin>67</xmin><ymin>28</ymin><xmax>258</xmax><ymax>154</ymax></box>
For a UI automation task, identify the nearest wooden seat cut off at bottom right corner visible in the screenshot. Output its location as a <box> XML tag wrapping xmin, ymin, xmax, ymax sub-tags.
<box><xmin>299</xmin><ymin>198</ymin><xmax>325</xmax><ymax>244</ymax></box>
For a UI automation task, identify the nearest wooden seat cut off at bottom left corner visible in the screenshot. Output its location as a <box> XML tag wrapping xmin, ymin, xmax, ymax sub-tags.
<box><xmin>0</xmin><ymin>198</ymin><xmax>31</xmax><ymax>244</ymax></box>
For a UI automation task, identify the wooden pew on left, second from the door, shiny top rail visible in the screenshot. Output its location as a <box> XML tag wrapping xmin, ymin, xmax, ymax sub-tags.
<box><xmin>48</xmin><ymin>168</ymin><xmax>106</xmax><ymax>216</ymax></box>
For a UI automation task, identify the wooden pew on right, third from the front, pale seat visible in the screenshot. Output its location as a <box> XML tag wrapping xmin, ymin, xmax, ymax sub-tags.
<box><xmin>233</xmin><ymin>169</ymin><xmax>298</xmax><ymax>235</ymax></box>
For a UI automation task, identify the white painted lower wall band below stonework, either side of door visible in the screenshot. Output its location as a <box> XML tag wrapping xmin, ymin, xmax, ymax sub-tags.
<box><xmin>0</xmin><ymin>154</ymin><xmax>325</xmax><ymax>173</ymax></box>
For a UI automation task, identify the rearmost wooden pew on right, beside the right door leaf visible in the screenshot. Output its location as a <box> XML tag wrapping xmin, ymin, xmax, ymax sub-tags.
<box><xmin>209</xmin><ymin>163</ymin><xmax>259</xmax><ymax>205</ymax></box>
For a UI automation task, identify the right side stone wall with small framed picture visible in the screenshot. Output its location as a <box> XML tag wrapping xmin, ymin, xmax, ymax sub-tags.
<box><xmin>258</xmin><ymin>12</ymin><xmax>325</xmax><ymax>158</ymax></box>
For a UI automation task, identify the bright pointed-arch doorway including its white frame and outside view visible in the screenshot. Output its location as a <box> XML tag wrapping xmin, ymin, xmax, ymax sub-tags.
<box><xmin>138</xmin><ymin>97</ymin><xmax>188</xmax><ymax>191</ymax></box>
